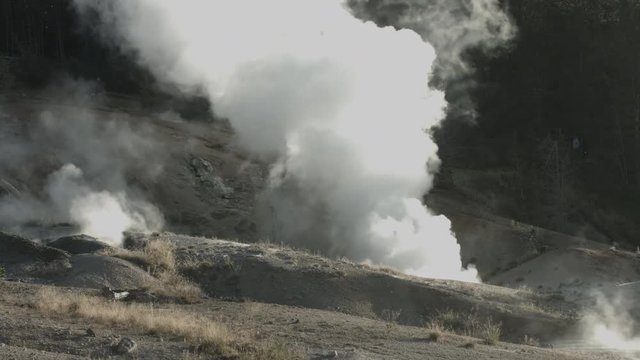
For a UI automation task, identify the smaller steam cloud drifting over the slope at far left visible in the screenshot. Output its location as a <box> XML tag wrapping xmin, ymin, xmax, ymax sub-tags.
<box><xmin>0</xmin><ymin>83</ymin><xmax>163</xmax><ymax>245</ymax></box>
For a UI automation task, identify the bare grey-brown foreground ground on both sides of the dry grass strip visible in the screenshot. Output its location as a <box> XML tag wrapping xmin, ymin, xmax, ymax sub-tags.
<box><xmin>0</xmin><ymin>272</ymin><xmax>617</xmax><ymax>360</ymax></box>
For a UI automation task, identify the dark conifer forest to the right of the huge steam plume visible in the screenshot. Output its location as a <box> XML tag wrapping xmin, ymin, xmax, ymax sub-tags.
<box><xmin>438</xmin><ymin>0</ymin><xmax>640</xmax><ymax>244</ymax></box>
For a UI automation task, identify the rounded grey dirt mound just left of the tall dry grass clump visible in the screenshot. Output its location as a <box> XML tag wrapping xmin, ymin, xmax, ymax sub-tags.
<box><xmin>44</xmin><ymin>254</ymin><xmax>159</xmax><ymax>289</ymax></box>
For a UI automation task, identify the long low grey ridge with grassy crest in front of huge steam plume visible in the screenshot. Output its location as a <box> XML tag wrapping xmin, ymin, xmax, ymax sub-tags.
<box><xmin>144</xmin><ymin>234</ymin><xmax>572</xmax><ymax>341</ymax></box>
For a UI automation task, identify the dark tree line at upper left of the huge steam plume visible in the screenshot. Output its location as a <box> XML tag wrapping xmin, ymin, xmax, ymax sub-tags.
<box><xmin>0</xmin><ymin>0</ymin><xmax>211</xmax><ymax>120</ymax></box>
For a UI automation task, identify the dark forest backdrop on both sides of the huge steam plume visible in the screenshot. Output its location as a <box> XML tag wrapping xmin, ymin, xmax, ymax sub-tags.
<box><xmin>0</xmin><ymin>0</ymin><xmax>640</xmax><ymax>245</ymax></box>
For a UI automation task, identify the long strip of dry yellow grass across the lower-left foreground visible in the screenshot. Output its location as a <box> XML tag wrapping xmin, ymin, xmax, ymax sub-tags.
<box><xmin>31</xmin><ymin>288</ymin><xmax>303</xmax><ymax>360</ymax></box>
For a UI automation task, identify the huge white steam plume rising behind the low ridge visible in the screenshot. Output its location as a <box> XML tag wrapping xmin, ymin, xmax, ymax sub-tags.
<box><xmin>75</xmin><ymin>0</ymin><xmax>512</xmax><ymax>281</ymax></box>
